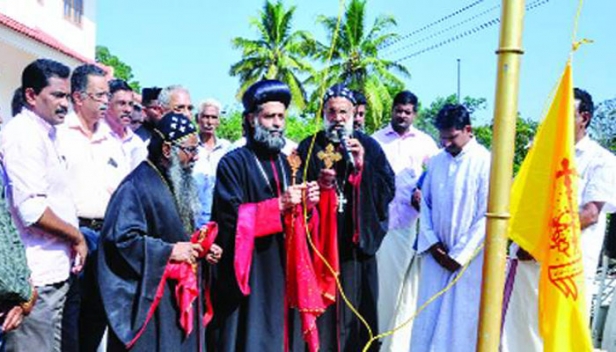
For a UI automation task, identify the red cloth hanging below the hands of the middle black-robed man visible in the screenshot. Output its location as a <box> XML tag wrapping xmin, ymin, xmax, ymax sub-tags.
<box><xmin>284</xmin><ymin>205</ymin><xmax>326</xmax><ymax>352</ymax></box>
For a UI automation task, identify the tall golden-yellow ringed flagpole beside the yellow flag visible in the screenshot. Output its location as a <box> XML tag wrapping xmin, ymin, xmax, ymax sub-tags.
<box><xmin>477</xmin><ymin>0</ymin><xmax>525</xmax><ymax>352</ymax></box>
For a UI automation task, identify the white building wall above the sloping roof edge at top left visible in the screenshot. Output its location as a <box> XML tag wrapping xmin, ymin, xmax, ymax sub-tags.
<box><xmin>0</xmin><ymin>0</ymin><xmax>96</xmax><ymax>60</ymax></box>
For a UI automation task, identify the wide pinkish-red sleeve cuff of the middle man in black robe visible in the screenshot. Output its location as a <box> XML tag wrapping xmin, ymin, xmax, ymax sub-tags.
<box><xmin>233</xmin><ymin>198</ymin><xmax>282</xmax><ymax>296</ymax></box>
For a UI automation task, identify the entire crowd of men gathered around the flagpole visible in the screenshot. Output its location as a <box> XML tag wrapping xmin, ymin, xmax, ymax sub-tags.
<box><xmin>0</xmin><ymin>59</ymin><xmax>616</xmax><ymax>352</ymax></box>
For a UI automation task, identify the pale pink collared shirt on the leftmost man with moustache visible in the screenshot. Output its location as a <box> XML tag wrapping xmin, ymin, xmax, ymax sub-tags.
<box><xmin>0</xmin><ymin>109</ymin><xmax>77</xmax><ymax>286</ymax></box>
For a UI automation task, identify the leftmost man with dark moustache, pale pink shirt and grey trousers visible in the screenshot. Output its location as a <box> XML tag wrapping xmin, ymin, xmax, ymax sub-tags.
<box><xmin>0</xmin><ymin>59</ymin><xmax>88</xmax><ymax>351</ymax></box>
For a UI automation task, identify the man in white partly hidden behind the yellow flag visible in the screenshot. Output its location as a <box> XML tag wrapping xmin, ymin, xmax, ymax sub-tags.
<box><xmin>501</xmin><ymin>88</ymin><xmax>616</xmax><ymax>352</ymax></box>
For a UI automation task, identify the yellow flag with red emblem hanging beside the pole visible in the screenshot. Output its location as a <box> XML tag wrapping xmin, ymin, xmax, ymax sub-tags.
<box><xmin>509</xmin><ymin>61</ymin><xmax>592</xmax><ymax>352</ymax></box>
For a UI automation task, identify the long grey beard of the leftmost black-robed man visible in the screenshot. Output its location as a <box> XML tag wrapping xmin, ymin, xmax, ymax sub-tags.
<box><xmin>167</xmin><ymin>147</ymin><xmax>201</xmax><ymax>235</ymax></box>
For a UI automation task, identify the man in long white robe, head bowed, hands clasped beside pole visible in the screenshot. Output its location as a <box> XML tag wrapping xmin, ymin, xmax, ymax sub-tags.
<box><xmin>411</xmin><ymin>104</ymin><xmax>490</xmax><ymax>352</ymax></box>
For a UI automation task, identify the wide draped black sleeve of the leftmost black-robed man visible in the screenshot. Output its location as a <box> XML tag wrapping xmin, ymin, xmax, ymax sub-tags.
<box><xmin>97</xmin><ymin>177</ymin><xmax>173</xmax><ymax>344</ymax></box>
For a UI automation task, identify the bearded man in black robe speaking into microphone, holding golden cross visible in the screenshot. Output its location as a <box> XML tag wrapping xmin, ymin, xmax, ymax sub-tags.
<box><xmin>298</xmin><ymin>84</ymin><xmax>395</xmax><ymax>351</ymax></box>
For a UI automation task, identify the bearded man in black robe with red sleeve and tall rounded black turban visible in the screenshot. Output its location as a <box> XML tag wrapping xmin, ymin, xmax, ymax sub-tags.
<box><xmin>208</xmin><ymin>80</ymin><xmax>318</xmax><ymax>352</ymax></box>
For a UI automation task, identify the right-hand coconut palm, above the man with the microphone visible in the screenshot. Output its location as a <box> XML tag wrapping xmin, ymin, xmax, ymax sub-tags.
<box><xmin>306</xmin><ymin>0</ymin><xmax>410</xmax><ymax>132</ymax></box>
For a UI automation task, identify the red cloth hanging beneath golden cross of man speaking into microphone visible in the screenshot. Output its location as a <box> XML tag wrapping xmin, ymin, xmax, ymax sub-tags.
<box><xmin>312</xmin><ymin>188</ymin><xmax>340</xmax><ymax>306</ymax></box>
